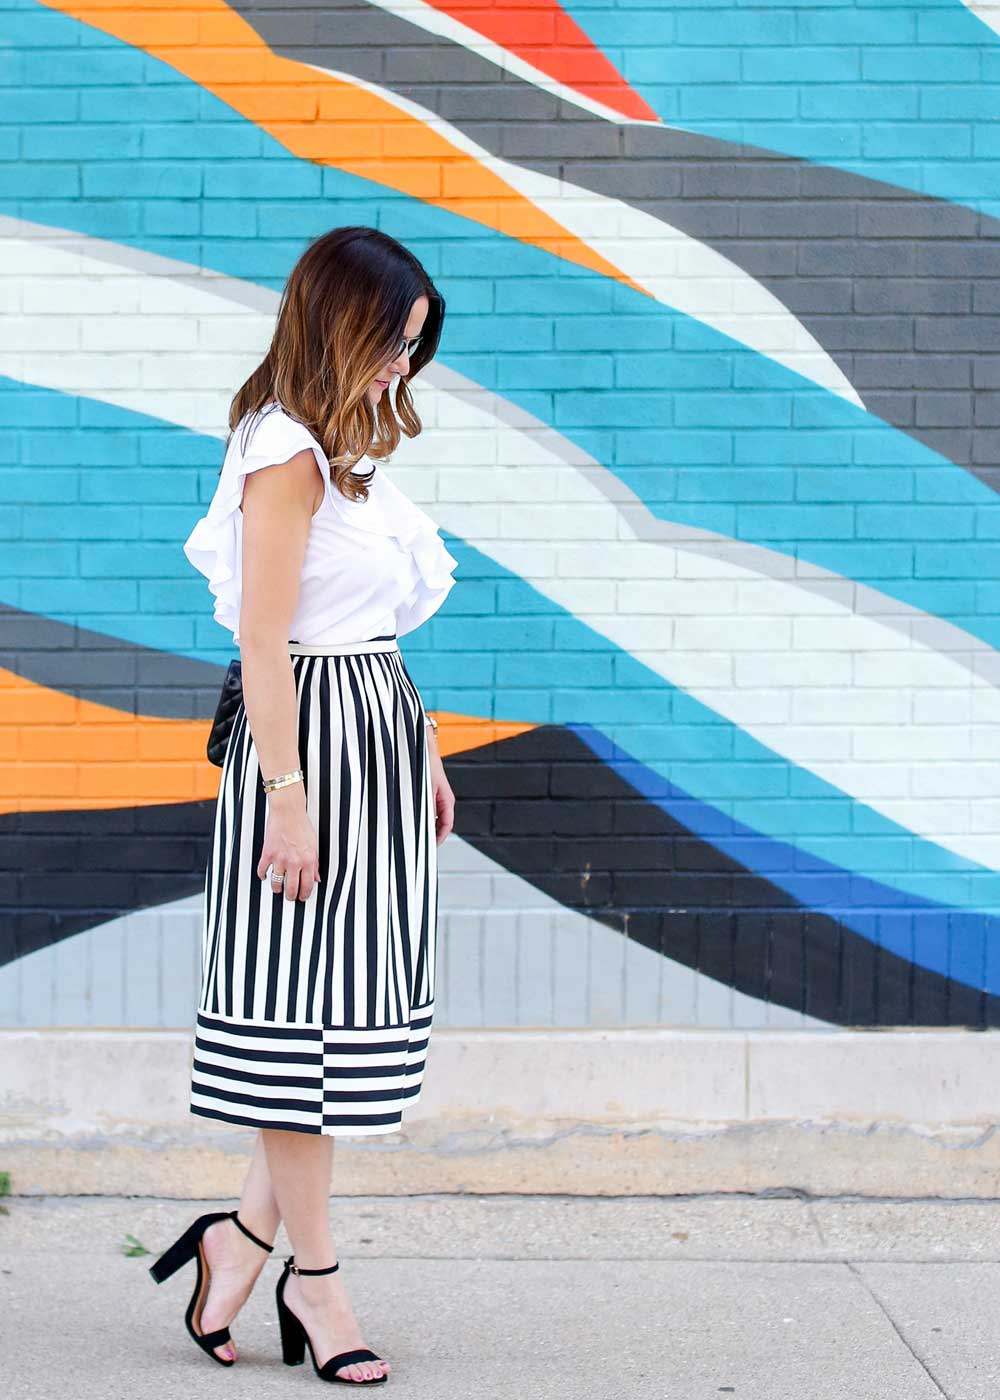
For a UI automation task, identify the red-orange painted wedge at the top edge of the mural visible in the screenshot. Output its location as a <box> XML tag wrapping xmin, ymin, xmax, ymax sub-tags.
<box><xmin>427</xmin><ymin>0</ymin><xmax>660</xmax><ymax>122</ymax></box>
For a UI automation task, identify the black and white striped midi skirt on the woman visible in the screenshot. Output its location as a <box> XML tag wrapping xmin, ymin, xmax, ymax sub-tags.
<box><xmin>190</xmin><ymin>636</ymin><xmax>437</xmax><ymax>1135</ymax></box>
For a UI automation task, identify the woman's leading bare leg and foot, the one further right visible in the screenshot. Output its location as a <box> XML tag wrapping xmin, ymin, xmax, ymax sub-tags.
<box><xmin>261</xmin><ymin>1128</ymin><xmax>392</xmax><ymax>1380</ymax></box>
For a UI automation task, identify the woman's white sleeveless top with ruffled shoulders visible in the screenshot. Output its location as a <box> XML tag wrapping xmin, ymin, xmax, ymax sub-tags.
<box><xmin>183</xmin><ymin>403</ymin><xmax>458</xmax><ymax>647</ymax></box>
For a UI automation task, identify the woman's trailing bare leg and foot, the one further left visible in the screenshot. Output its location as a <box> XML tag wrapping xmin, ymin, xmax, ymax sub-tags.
<box><xmin>196</xmin><ymin>1133</ymin><xmax>282</xmax><ymax>1359</ymax></box>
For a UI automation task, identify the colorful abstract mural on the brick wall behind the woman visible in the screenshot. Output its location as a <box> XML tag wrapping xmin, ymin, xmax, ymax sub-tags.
<box><xmin>0</xmin><ymin>0</ymin><xmax>1000</xmax><ymax>1028</ymax></box>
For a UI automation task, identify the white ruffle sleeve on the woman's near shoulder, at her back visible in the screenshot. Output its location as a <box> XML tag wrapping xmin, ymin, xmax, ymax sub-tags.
<box><xmin>183</xmin><ymin>409</ymin><xmax>329</xmax><ymax>634</ymax></box>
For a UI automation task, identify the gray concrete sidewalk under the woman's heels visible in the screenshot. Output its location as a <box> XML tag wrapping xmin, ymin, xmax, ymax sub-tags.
<box><xmin>0</xmin><ymin>1196</ymin><xmax>1000</xmax><ymax>1400</ymax></box>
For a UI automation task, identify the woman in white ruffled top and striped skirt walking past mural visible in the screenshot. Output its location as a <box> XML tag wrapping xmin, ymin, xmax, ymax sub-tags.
<box><xmin>151</xmin><ymin>227</ymin><xmax>457</xmax><ymax>1385</ymax></box>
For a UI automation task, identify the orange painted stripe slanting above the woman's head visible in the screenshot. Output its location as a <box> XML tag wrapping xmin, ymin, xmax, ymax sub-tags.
<box><xmin>42</xmin><ymin>0</ymin><xmax>646</xmax><ymax>294</ymax></box>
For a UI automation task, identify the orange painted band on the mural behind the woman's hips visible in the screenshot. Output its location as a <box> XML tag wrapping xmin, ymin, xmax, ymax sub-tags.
<box><xmin>0</xmin><ymin>669</ymin><xmax>536</xmax><ymax>815</ymax></box>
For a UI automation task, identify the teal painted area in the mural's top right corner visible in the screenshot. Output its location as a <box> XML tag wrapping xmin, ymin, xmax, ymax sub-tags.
<box><xmin>564</xmin><ymin>0</ymin><xmax>1000</xmax><ymax>217</ymax></box>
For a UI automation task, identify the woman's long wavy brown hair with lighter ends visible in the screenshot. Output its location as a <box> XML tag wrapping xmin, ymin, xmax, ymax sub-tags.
<box><xmin>227</xmin><ymin>224</ymin><xmax>444</xmax><ymax>500</ymax></box>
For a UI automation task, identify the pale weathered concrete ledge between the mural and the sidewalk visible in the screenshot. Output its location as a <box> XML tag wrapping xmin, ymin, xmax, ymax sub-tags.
<box><xmin>0</xmin><ymin>1028</ymin><xmax>1000</xmax><ymax>1198</ymax></box>
